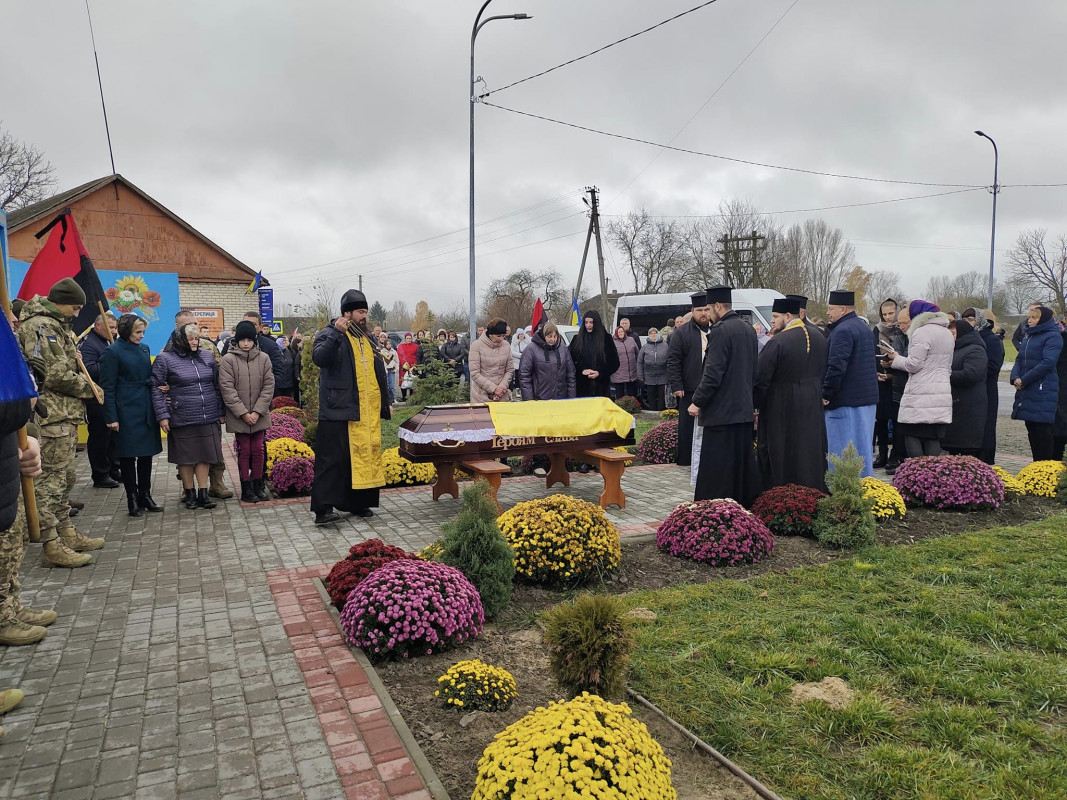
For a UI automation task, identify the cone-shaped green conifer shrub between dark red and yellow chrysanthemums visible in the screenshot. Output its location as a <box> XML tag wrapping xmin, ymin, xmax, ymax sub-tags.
<box><xmin>812</xmin><ymin>443</ymin><xmax>877</xmax><ymax>548</ymax></box>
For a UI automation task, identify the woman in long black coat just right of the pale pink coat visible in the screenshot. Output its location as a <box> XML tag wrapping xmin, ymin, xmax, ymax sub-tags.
<box><xmin>941</xmin><ymin>319</ymin><xmax>989</xmax><ymax>455</ymax></box>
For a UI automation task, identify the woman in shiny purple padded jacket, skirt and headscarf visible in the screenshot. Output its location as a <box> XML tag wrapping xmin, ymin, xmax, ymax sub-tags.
<box><xmin>152</xmin><ymin>325</ymin><xmax>225</xmax><ymax>509</ymax></box>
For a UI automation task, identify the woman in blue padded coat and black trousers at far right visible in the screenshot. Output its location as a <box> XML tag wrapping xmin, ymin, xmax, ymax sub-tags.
<box><xmin>1012</xmin><ymin>306</ymin><xmax>1064</xmax><ymax>461</ymax></box>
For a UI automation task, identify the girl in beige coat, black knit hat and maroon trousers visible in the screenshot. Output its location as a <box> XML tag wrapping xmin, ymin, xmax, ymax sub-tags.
<box><xmin>219</xmin><ymin>320</ymin><xmax>274</xmax><ymax>502</ymax></box>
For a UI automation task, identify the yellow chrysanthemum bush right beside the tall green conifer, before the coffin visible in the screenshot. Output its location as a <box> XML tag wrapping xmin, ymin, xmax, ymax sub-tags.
<box><xmin>496</xmin><ymin>495</ymin><xmax>622</xmax><ymax>586</ymax></box>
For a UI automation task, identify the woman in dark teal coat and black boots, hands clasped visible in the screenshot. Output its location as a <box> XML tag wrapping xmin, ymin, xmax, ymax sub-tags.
<box><xmin>100</xmin><ymin>314</ymin><xmax>163</xmax><ymax>516</ymax></box>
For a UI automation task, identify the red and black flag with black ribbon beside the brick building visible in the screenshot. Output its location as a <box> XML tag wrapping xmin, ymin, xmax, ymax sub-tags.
<box><xmin>18</xmin><ymin>208</ymin><xmax>108</xmax><ymax>334</ymax></box>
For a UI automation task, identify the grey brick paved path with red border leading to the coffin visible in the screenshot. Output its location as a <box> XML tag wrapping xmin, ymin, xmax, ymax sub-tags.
<box><xmin>0</xmin><ymin>454</ymin><xmax>691</xmax><ymax>800</ymax></box>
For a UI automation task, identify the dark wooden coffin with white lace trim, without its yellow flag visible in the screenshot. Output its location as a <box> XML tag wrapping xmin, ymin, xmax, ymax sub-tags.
<box><xmin>400</xmin><ymin>403</ymin><xmax>634</xmax><ymax>462</ymax></box>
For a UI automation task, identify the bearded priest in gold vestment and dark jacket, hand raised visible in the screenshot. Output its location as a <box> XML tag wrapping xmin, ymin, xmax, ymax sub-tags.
<box><xmin>312</xmin><ymin>289</ymin><xmax>392</xmax><ymax>525</ymax></box>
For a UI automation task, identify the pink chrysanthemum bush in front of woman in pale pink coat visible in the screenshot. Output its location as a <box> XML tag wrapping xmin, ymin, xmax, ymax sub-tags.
<box><xmin>893</xmin><ymin>455</ymin><xmax>1004</xmax><ymax>511</ymax></box>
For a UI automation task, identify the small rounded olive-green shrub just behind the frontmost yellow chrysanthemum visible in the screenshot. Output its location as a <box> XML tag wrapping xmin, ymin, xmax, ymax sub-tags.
<box><xmin>544</xmin><ymin>594</ymin><xmax>635</xmax><ymax>698</ymax></box>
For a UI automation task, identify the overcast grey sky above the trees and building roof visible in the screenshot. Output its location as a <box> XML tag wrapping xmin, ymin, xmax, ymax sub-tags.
<box><xmin>0</xmin><ymin>0</ymin><xmax>1067</xmax><ymax>310</ymax></box>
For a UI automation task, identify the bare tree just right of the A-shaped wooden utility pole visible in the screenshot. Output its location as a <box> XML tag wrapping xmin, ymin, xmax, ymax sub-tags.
<box><xmin>607</xmin><ymin>208</ymin><xmax>689</xmax><ymax>294</ymax></box>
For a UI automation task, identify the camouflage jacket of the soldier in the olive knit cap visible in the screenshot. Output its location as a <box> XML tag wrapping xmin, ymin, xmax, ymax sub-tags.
<box><xmin>18</xmin><ymin>295</ymin><xmax>96</xmax><ymax>425</ymax></box>
